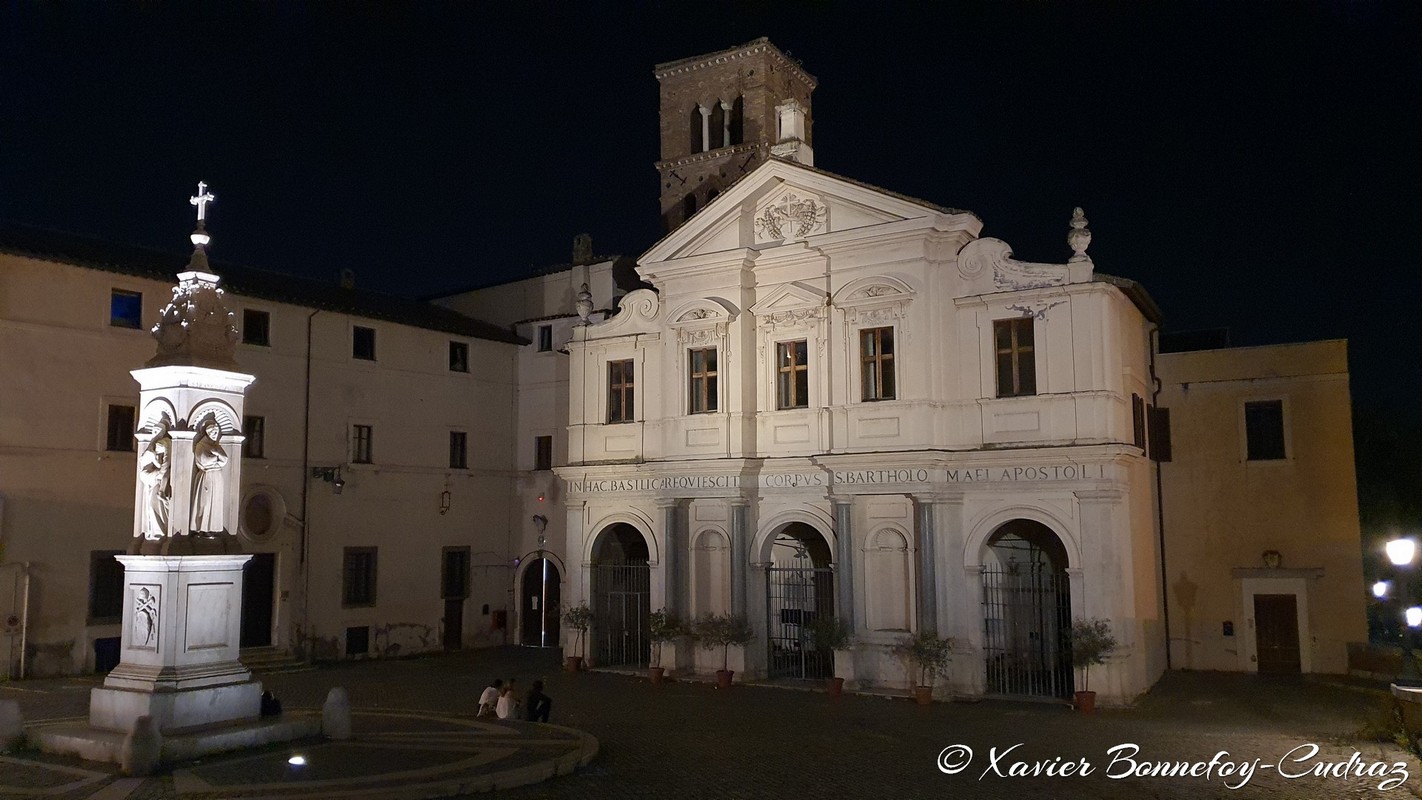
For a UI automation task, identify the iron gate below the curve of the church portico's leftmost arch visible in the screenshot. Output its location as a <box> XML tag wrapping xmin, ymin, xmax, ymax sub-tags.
<box><xmin>592</xmin><ymin>563</ymin><xmax>651</xmax><ymax>666</ymax></box>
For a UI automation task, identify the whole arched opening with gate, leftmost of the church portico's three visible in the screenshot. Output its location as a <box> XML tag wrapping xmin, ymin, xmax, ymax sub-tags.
<box><xmin>590</xmin><ymin>523</ymin><xmax>651</xmax><ymax>666</ymax></box>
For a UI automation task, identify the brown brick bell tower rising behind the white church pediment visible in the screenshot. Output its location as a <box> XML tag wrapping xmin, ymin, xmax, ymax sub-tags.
<box><xmin>656</xmin><ymin>37</ymin><xmax>816</xmax><ymax>232</ymax></box>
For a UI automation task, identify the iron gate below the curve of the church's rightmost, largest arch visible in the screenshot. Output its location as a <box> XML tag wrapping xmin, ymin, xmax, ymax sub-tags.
<box><xmin>983</xmin><ymin>561</ymin><xmax>1072</xmax><ymax>698</ymax></box>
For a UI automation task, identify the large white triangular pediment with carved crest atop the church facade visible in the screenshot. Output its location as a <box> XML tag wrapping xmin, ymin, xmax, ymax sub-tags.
<box><xmin>638</xmin><ymin>159</ymin><xmax>961</xmax><ymax>264</ymax></box>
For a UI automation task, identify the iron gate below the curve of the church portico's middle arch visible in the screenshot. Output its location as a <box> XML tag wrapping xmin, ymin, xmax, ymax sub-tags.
<box><xmin>765</xmin><ymin>567</ymin><xmax>835</xmax><ymax>679</ymax></box>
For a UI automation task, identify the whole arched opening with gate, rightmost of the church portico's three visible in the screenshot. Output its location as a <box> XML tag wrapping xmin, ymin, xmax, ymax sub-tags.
<box><xmin>983</xmin><ymin>519</ymin><xmax>1072</xmax><ymax>698</ymax></box>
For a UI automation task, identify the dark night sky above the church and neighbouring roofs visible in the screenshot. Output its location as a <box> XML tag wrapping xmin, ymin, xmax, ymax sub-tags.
<box><xmin>0</xmin><ymin>6</ymin><xmax>1422</xmax><ymax>413</ymax></box>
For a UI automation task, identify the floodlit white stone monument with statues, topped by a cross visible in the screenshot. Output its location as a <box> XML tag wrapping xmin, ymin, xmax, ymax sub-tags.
<box><xmin>41</xmin><ymin>183</ymin><xmax>313</xmax><ymax>769</ymax></box>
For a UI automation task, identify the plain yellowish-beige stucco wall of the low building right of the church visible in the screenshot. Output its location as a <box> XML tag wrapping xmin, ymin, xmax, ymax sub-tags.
<box><xmin>1158</xmin><ymin>340</ymin><xmax>1367</xmax><ymax>672</ymax></box>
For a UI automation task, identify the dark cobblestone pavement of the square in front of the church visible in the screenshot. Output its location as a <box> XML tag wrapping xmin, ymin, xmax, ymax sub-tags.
<box><xmin>0</xmin><ymin>648</ymin><xmax>1422</xmax><ymax>800</ymax></box>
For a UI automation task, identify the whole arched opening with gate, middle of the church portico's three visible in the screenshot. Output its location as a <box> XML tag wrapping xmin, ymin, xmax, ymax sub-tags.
<box><xmin>765</xmin><ymin>521</ymin><xmax>835</xmax><ymax>679</ymax></box>
